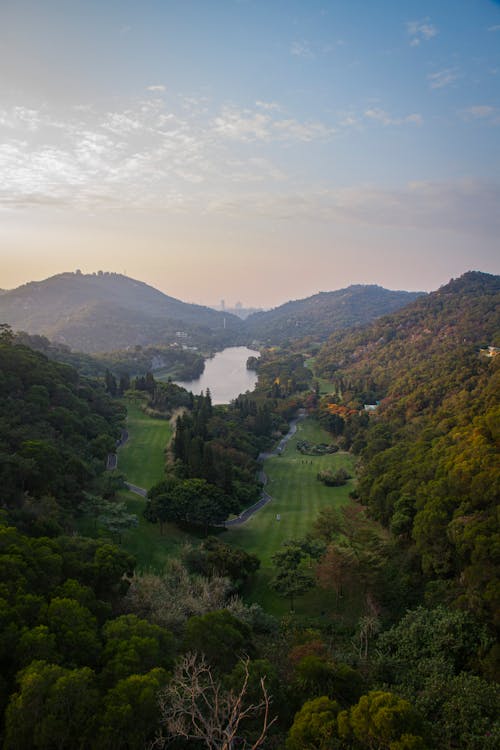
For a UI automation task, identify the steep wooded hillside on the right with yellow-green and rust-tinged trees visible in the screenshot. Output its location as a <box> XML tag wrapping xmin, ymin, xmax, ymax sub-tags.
<box><xmin>316</xmin><ymin>272</ymin><xmax>500</xmax><ymax>648</ymax></box>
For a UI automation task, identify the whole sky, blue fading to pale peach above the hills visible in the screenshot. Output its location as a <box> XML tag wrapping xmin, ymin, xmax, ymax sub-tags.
<box><xmin>0</xmin><ymin>0</ymin><xmax>500</xmax><ymax>307</ymax></box>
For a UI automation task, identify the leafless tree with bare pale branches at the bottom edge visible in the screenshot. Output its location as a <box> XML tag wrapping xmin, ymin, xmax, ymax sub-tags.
<box><xmin>155</xmin><ymin>653</ymin><xmax>276</xmax><ymax>750</ymax></box>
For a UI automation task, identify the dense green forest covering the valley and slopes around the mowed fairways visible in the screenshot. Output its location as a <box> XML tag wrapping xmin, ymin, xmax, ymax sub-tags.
<box><xmin>0</xmin><ymin>273</ymin><xmax>500</xmax><ymax>750</ymax></box>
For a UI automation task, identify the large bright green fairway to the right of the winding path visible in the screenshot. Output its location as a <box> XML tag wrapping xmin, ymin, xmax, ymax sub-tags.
<box><xmin>222</xmin><ymin>417</ymin><xmax>354</xmax><ymax>616</ymax></box>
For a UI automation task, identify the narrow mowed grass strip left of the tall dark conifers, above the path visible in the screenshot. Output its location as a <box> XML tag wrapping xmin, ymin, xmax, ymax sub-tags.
<box><xmin>118</xmin><ymin>401</ymin><xmax>172</xmax><ymax>489</ymax></box>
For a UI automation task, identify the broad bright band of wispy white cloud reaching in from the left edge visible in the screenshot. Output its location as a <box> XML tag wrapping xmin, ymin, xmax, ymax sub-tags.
<box><xmin>0</xmin><ymin>92</ymin><xmax>333</xmax><ymax>212</ymax></box>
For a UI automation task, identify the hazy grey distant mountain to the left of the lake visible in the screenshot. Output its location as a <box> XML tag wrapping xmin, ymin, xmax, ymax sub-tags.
<box><xmin>0</xmin><ymin>272</ymin><xmax>243</xmax><ymax>353</ymax></box>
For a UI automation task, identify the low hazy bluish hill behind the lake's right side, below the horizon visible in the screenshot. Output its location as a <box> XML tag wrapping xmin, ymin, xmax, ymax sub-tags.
<box><xmin>246</xmin><ymin>284</ymin><xmax>423</xmax><ymax>344</ymax></box>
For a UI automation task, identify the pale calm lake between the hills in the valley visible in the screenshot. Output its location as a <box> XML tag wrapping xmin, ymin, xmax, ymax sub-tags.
<box><xmin>175</xmin><ymin>346</ymin><xmax>259</xmax><ymax>404</ymax></box>
